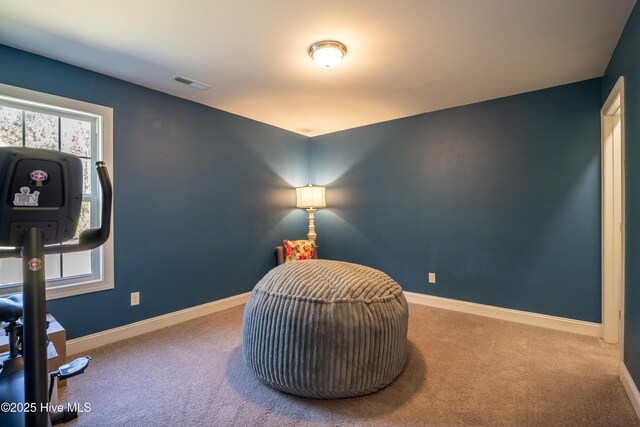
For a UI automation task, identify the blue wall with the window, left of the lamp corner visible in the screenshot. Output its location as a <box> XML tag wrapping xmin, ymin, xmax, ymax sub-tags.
<box><xmin>0</xmin><ymin>45</ymin><xmax>309</xmax><ymax>338</ymax></box>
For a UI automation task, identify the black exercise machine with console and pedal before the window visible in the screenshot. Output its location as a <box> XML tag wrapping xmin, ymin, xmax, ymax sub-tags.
<box><xmin>0</xmin><ymin>147</ymin><xmax>112</xmax><ymax>427</ymax></box>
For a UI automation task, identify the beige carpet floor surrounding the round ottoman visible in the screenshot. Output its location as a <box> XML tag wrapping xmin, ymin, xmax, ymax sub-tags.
<box><xmin>61</xmin><ymin>304</ymin><xmax>640</xmax><ymax>426</ymax></box>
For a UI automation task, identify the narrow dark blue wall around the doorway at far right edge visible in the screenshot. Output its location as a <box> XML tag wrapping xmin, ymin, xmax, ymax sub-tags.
<box><xmin>602</xmin><ymin>0</ymin><xmax>640</xmax><ymax>394</ymax></box>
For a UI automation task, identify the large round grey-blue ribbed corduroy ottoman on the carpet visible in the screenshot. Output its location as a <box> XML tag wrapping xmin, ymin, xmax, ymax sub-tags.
<box><xmin>242</xmin><ymin>260</ymin><xmax>409</xmax><ymax>399</ymax></box>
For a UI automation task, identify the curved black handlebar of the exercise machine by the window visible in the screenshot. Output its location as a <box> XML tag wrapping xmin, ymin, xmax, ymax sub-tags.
<box><xmin>0</xmin><ymin>162</ymin><xmax>113</xmax><ymax>258</ymax></box>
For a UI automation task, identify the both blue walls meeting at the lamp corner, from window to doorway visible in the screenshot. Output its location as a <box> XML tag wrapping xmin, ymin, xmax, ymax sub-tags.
<box><xmin>0</xmin><ymin>41</ymin><xmax>602</xmax><ymax>337</ymax></box>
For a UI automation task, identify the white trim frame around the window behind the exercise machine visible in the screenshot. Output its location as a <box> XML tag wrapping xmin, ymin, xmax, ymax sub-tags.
<box><xmin>0</xmin><ymin>83</ymin><xmax>115</xmax><ymax>300</ymax></box>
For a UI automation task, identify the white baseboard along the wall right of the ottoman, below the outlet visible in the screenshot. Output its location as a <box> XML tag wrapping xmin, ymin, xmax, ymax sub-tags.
<box><xmin>404</xmin><ymin>291</ymin><xmax>602</xmax><ymax>337</ymax></box>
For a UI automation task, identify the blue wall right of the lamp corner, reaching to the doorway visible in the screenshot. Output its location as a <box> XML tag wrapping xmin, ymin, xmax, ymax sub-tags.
<box><xmin>311</xmin><ymin>79</ymin><xmax>601</xmax><ymax>322</ymax></box>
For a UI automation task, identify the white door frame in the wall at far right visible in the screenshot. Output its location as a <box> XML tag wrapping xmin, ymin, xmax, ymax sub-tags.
<box><xmin>600</xmin><ymin>77</ymin><xmax>625</xmax><ymax>350</ymax></box>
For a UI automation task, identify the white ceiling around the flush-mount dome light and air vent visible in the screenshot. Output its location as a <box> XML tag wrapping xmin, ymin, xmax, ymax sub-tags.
<box><xmin>0</xmin><ymin>0</ymin><xmax>634</xmax><ymax>136</ymax></box>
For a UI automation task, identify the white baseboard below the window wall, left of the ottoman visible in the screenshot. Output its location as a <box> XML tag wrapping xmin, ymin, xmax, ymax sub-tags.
<box><xmin>67</xmin><ymin>292</ymin><xmax>251</xmax><ymax>355</ymax></box>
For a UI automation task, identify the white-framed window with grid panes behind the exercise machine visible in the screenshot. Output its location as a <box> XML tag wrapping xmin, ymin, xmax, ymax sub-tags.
<box><xmin>0</xmin><ymin>84</ymin><xmax>113</xmax><ymax>299</ymax></box>
